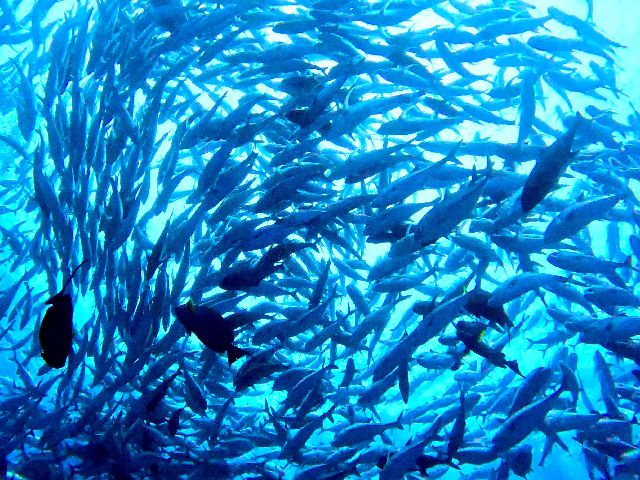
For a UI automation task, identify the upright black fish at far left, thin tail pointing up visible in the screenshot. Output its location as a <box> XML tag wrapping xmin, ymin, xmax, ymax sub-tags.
<box><xmin>38</xmin><ymin>260</ymin><xmax>87</xmax><ymax>368</ymax></box>
